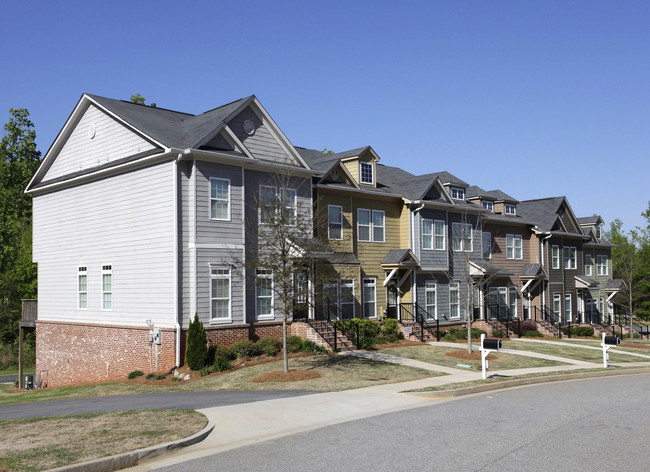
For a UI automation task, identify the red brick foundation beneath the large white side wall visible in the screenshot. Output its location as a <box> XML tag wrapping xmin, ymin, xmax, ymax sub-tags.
<box><xmin>36</xmin><ymin>321</ymin><xmax>176</xmax><ymax>387</ymax></box>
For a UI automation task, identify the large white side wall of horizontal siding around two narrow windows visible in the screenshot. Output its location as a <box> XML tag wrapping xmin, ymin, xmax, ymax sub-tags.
<box><xmin>33</xmin><ymin>163</ymin><xmax>174</xmax><ymax>327</ymax></box>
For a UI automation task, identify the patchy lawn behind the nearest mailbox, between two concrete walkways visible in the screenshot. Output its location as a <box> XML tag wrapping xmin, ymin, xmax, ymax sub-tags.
<box><xmin>381</xmin><ymin>344</ymin><xmax>565</xmax><ymax>370</ymax></box>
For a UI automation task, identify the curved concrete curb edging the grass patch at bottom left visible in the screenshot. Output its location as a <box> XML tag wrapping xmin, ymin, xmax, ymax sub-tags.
<box><xmin>49</xmin><ymin>423</ymin><xmax>214</xmax><ymax>472</ymax></box>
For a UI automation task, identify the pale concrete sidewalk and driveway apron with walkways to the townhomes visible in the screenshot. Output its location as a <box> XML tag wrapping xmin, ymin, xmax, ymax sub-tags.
<box><xmin>114</xmin><ymin>343</ymin><xmax>650</xmax><ymax>471</ymax></box>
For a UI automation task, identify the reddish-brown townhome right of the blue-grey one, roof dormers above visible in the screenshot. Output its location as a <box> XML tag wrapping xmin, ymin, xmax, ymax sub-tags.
<box><xmin>467</xmin><ymin>186</ymin><xmax>545</xmax><ymax>319</ymax></box>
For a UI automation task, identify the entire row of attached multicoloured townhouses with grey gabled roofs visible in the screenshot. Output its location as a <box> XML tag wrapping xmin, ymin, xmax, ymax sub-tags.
<box><xmin>27</xmin><ymin>94</ymin><xmax>616</xmax><ymax>385</ymax></box>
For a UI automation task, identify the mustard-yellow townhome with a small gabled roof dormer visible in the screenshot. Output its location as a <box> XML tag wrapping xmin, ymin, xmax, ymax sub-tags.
<box><xmin>297</xmin><ymin>146</ymin><xmax>414</xmax><ymax>319</ymax></box>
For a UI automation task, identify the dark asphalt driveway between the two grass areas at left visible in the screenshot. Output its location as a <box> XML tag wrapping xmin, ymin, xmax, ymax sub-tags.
<box><xmin>0</xmin><ymin>390</ymin><xmax>311</xmax><ymax>419</ymax></box>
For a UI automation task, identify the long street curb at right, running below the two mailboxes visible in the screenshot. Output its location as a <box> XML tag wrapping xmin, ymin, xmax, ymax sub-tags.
<box><xmin>401</xmin><ymin>367</ymin><xmax>650</xmax><ymax>398</ymax></box>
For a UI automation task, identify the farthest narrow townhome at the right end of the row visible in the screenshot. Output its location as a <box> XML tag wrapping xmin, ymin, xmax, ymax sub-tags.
<box><xmin>578</xmin><ymin>215</ymin><xmax>620</xmax><ymax>324</ymax></box>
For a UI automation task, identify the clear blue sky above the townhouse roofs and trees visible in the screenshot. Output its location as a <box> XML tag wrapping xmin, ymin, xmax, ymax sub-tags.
<box><xmin>0</xmin><ymin>0</ymin><xmax>650</xmax><ymax>229</ymax></box>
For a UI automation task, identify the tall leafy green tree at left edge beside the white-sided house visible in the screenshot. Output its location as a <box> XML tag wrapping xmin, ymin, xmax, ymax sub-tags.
<box><xmin>0</xmin><ymin>108</ymin><xmax>41</xmax><ymax>343</ymax></box>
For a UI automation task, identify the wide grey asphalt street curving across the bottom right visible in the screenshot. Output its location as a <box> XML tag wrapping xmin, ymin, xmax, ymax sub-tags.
<box><xmin>160</xmin><ymin>375</ymin><xmax>650</xmax><ymax>472</ymax></box>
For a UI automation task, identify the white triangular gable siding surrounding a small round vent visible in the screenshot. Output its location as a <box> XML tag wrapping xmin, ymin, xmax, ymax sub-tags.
<box><xmin>43</xmin><ymin>105</ymin><xmax>154</xmax><ymax>181</ymax></box>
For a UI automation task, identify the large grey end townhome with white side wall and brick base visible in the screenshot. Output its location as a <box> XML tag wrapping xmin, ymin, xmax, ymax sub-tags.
<box><xmin>27</xmin><ymin>94</ymin><xmax>312</xmax><ymax>385</ymax></box>
